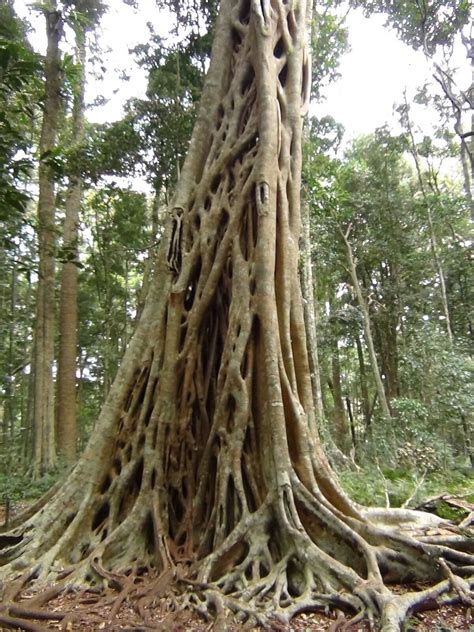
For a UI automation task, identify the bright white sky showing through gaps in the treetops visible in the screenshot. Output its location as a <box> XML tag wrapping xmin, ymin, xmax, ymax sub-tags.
<box><xmin>15</xmin><ymin>0</ymin><xmax>468</xmax><ymax>140</ymax></box>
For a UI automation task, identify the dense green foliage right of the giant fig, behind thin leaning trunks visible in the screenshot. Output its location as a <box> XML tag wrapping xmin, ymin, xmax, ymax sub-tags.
<box><xmin>305</xmin><ymin>125</ymin><xmax>474</xmax><ymax>464</ymax></box>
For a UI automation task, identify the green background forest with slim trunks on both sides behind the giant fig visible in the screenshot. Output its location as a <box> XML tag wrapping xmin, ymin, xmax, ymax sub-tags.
<box><xmin>0</xmin><ymin>0</ymin><xmax>474</xmax><ymax>506</ymax></box>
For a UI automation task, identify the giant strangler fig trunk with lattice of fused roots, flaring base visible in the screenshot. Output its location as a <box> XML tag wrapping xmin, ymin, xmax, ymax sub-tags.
<box><xmin>0</xmin><ymin>0</ymin><xmax>474</xmax><ymax>631</ymax></box>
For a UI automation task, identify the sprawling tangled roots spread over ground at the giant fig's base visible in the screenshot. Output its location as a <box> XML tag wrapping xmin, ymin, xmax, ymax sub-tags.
<box><xmin>0</xmin><ymin>476</ymin><xmax>474</xmax><ymax>632</ymax></box>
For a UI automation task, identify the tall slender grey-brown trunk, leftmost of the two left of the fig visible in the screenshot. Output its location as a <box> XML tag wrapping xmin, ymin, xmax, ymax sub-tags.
<box><xmin>34</xmin><ymin>1</ymin><xmax>61</xmax><ymax>476</ymax></box>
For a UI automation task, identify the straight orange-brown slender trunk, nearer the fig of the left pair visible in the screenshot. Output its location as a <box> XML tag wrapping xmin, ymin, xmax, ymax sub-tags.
<box><xmin>57</xmin><ymin>26</ymin><xmax>86</xmax><ymax>465</ymax></box>
